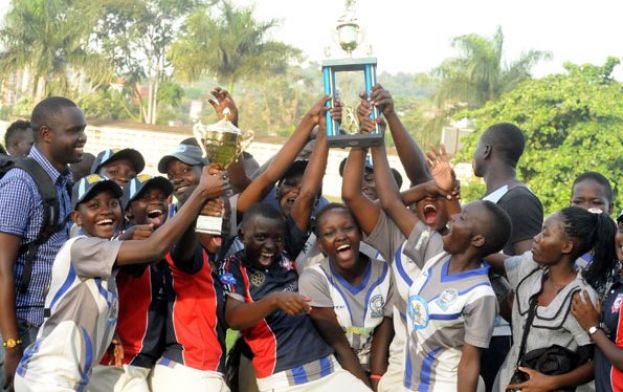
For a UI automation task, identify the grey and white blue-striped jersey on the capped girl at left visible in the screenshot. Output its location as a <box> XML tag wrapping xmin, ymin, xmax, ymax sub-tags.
<box><xmin>17</xmin><ymin>236</ymin><xmax>121</xmax><ymax>390</ymax></box>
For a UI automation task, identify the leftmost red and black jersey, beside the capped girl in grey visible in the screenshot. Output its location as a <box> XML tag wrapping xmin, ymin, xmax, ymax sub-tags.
<box><xmin>100</xmin><ymin>260</ymin><xmax>169</xmax><ymax>368</ymax></box>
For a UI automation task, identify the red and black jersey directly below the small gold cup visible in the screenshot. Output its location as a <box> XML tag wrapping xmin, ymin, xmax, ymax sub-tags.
<box><xmin>160</xmin><ymin>245</ymin><xmax>227</xmax><ymax>372</ymax></box>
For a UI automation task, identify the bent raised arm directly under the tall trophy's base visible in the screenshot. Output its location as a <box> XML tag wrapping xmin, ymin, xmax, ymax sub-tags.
<box><xmin>342</xmin><ymin>148</ymin><xmax>381</xmax><ymax>235</ymax></box>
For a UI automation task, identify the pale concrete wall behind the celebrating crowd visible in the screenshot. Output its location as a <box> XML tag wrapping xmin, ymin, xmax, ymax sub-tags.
<box><xmin>0</xmin><ymin>121</ymin><xmax>409</xmax><ymax>199</ymax></box>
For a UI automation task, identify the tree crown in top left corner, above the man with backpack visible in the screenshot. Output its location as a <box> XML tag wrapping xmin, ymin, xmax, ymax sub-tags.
<box><xmin>0</xmin><ymin>0</ymin><xmax>112</xmax><ymax>102</ymax></box>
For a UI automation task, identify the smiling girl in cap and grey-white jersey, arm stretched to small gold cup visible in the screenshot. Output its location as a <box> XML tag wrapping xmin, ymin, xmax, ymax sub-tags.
<box><xmin>15</xmin><ymin>171</ymin><xmax>222</xmax><ymax>391</ymax></box>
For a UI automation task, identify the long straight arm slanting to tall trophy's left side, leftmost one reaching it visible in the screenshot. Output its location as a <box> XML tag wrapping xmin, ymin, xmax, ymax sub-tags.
<box><xmin>237</xmin><ymin>96</ymin><xmax>329</xmax><ymax>213</ymax></box>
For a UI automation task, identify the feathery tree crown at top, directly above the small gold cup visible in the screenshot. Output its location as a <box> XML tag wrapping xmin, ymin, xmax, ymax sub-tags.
<box><xmin>169</xmin><ymin>0</ymin><xmax>299</xmax><ymax>92</ymax></box>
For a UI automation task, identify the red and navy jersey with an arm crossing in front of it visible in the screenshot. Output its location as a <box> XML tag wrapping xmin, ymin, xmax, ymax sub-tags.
<box><xmin>219</xmin><ymin>250</ymin><xmax>333</xmax><ymax>378</ymax></box>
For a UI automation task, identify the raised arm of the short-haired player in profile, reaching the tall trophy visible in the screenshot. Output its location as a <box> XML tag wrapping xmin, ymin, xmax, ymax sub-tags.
<box><xmin>372</xmin><ymin>144</ymin><xmax>418</xmax><ymax>237</ymax></box>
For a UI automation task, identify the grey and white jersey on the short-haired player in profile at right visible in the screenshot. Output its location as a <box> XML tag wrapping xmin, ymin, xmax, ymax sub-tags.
<box><xmin>404</xmin><ymin>252</ymin><xmax>497</xmax><ymax>392</ymax></box>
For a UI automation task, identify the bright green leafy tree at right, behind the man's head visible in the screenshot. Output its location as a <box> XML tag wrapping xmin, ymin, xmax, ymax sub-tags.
<box><xmin>456</xmin><ymin>58</ymin><xmax>623</xmax><ymax>212</ymax></box>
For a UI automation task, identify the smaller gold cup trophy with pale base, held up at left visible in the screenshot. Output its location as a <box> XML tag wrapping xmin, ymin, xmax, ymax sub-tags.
<box><xmin>193</xmin><ymin>108</ymin><xmax>253</xmax><ymax>235</ymax></box>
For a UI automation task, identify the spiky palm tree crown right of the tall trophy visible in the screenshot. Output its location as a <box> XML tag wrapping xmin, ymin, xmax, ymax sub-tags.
<box><xmin>433</xmin><ymin>27</ymin><xmax>550</xmax><ymax>108</ymax></box>
